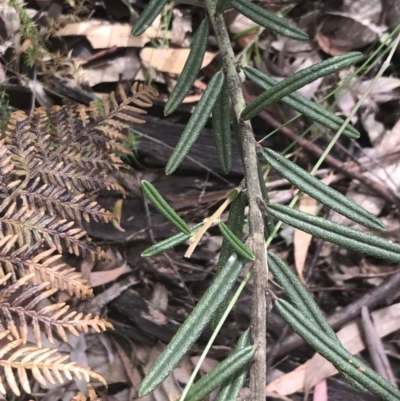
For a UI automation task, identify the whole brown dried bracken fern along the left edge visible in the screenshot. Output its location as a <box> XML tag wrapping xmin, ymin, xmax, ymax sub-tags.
<box><xmin>0</xmin><ymin>84</ymin><xmax>157</xmax><ymax>396</ymax></box>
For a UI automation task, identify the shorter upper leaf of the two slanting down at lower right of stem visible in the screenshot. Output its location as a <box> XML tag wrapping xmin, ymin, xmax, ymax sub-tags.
<box><xmin>268</xmin><ymin>252</ymin><xmax>339</xmax><ymax>341</ymax></box>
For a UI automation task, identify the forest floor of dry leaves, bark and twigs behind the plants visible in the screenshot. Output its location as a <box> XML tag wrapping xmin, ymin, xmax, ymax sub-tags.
<box><xmin>0</xmin><ymin>0</ymin><xmax>400</xmax><ymax>401</ymax></box>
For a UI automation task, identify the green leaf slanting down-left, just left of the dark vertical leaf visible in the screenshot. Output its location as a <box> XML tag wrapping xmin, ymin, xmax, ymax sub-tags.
<box><xmin>165</xmin><ymin>71</ymin><xmax>225</xmax><ymax>175</ymax></box>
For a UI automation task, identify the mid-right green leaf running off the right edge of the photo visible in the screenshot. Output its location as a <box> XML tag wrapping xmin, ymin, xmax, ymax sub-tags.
<box><xmin>268</xmin><ymin>203</ymin><xmax>400</xmax><ymax>263</ymax></box>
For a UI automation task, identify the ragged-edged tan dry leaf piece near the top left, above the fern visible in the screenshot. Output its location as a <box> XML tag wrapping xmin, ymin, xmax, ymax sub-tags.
<box><xmin>56</xmin><ymin>19</ymin><xmax>170</xmax><ymax>49</ymax></box>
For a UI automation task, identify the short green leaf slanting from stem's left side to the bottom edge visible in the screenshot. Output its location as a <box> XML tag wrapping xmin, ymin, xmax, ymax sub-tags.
<box><xmin>186</xmin><ymin>345</ymin><xmax>254</xmax><ymax>401</ymax></box>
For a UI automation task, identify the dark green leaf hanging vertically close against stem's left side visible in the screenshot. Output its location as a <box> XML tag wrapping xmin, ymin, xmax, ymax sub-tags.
<box><xmin>212</xmin><ymin>76</ymin><xmax>232</xmax><ymax>174</ymax></box>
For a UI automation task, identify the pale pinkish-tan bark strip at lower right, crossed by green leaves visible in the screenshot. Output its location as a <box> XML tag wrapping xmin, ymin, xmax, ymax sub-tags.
<box><xmin>267</xmin><ymin>303</ymin><xmax>400</xmax><ymax>395</ymax></box>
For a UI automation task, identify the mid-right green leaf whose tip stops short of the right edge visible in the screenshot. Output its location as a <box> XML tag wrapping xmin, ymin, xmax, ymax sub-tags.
<box><xmin>263</xmin><ymin>149</ymin><xmax>385</xmax><ymax>231</ymax></box>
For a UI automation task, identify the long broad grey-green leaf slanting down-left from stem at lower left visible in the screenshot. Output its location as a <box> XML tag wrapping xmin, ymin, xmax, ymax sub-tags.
<box><xmin>139</xmin><ymin>254</ymin><xmax>245</xmax><ymax>396</ymax></box>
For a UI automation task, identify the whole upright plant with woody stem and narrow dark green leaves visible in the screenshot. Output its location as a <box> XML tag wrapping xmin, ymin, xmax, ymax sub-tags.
<box><xmin>132</xmin><ymin>0</ymin><xmax>400</xmax><ymax>401</ymax></box>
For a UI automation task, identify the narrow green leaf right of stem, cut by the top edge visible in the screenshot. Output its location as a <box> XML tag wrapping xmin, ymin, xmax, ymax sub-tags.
<box><xmin>232</xmin><ymin>0</ymin><xmax>308</xmax><ymax>40</ymax></box>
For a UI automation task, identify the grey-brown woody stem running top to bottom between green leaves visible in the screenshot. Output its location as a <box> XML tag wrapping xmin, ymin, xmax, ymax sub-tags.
<box><xmin>206</xmin><ymin>0</ymin><xmax>267</xmax><ymax>401</ymax></box>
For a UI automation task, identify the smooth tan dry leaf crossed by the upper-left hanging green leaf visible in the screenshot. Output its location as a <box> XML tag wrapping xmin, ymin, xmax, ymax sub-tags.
<box><xmin>140</xmin><ymin>47</ymin><xmax>218</xmax><ymax>74</ymax></box>
